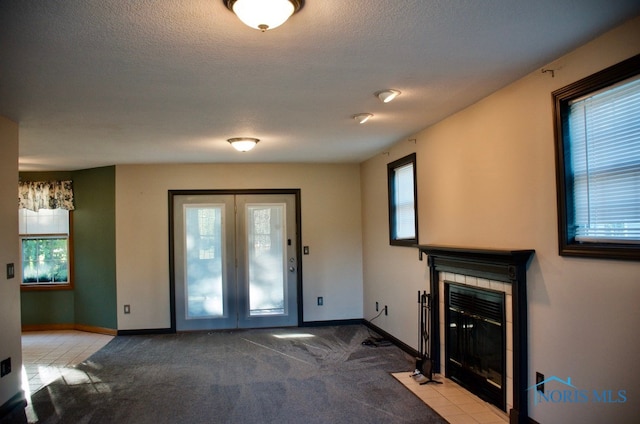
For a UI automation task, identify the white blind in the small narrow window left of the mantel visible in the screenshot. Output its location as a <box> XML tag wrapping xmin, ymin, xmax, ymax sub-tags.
<box><xmin>394</xmin><ymin>163</ymin><xmax>416</xmax><ymax>240</ymax></box>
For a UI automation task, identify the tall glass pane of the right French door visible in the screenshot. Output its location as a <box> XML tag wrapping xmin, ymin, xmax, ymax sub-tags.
<box><xmin>246</xmin><ymin>204</ymin><xmax>287</xmax><ymax>316</ymax></box>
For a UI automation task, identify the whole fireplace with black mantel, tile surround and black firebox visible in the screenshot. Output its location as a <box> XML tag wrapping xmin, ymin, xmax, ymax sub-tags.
<box><xmin>418</xmin><ymin>245</ymin><xmax>535</xmax><ymax>424</ymax></box>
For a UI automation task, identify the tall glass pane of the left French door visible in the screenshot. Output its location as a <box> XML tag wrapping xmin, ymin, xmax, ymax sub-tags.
<box><xmin>184</xmin><ymin>204</ymin><xmax>225</xmax><ymax>319</ymax></box>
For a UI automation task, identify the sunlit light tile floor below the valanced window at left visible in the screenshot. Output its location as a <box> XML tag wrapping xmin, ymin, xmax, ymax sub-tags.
<box><xmin>22</xmin><ymin>330</ymin><xmax>113</xmax><ymax>402</ymax></box>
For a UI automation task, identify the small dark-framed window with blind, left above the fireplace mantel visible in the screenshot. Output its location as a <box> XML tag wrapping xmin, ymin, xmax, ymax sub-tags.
<box><xmin>387</xmin><ymin>153</ymin><xmax>418</xmax><ymax>246</ymax></box>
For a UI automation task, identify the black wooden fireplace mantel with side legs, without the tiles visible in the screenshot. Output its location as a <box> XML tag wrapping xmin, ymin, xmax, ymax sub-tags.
<box><xmin>417</xmin><ymin>245</ymin><xmax>535</xmax><ymax>424</ymax></box>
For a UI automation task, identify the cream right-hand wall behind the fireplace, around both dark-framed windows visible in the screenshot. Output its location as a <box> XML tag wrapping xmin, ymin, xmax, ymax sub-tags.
<box><xmin>361</xmin><ymin>18</ymin><xmax>640</xmax><ymax>423</ymax></box>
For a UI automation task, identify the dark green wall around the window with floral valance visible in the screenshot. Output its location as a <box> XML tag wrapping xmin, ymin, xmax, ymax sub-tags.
<box><xmin>20</xmin><ymin>166</ymin><xmax>117</xmax><ymax>329</ymax></box>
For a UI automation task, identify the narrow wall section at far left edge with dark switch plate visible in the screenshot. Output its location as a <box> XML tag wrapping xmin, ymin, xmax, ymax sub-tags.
<box><xmin>0</xmin><ymin>116</ymin><xmax>22</xmax><ymax>406</ymax></box>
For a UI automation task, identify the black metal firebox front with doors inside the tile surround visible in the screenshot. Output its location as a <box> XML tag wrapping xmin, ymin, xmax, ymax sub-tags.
<box><xmin>445</xmin><ymin>283</ymin><xmax>506</xmax><ymax>410</ymax></box>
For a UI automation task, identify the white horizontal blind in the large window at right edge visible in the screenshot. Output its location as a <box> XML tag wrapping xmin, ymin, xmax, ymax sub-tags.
<box><xmin>569</xmin><ymin>77</ymin><xmax>640</xmax><ymax>243</ymax></box>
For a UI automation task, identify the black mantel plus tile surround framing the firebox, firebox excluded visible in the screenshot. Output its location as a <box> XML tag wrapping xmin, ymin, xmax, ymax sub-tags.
<box><xmin>419</xmin><ymin>246</ymin><xmax>534</xmax><ymax>424</ymax></box>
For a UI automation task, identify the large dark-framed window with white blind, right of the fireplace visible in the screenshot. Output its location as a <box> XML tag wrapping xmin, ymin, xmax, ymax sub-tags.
<box><xmin>553</xmin><ymin>55</ymin><xmax>640</xmax><ymax>259</ymax></box>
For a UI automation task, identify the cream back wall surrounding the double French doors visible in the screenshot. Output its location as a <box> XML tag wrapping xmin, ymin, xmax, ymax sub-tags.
<box><xmin>116</xmin><ymin>164</ymin><xmax>362</xmax><ymax>330</ymax></box>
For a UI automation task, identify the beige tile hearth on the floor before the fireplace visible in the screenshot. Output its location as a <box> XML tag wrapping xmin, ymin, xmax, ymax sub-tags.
<box><xmin>393</xmin><ymin>372</ymin><xmax>509</xmax><ymax>424</ymax></box>
